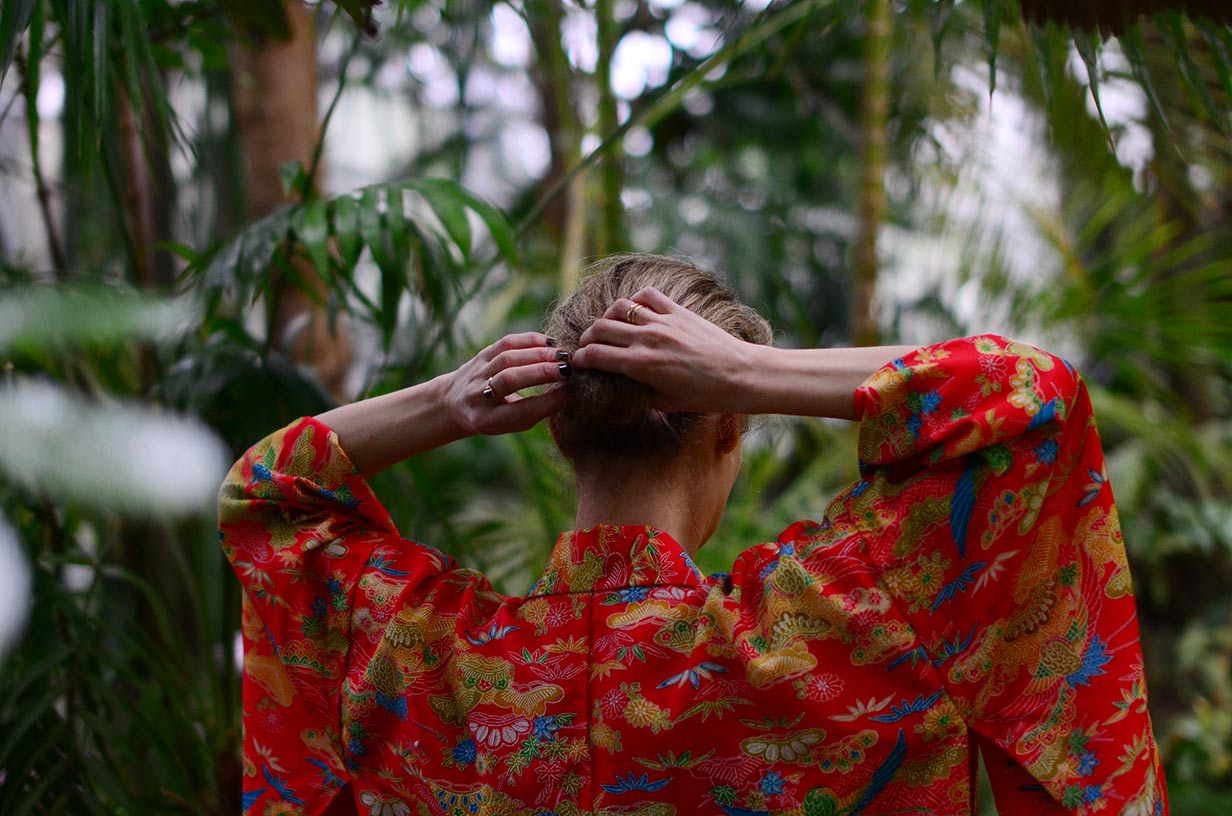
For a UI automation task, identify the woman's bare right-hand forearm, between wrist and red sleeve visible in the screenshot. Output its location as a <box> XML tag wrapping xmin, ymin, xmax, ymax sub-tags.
<box><xmin>737</xmin><ymin>345</ymin><xmax>915</xmax><ymax>419</ymax></box>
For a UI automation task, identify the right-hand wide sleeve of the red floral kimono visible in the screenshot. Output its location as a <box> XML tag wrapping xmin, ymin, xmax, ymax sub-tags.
<box><xmin>856</xmin><ymin>335</ymin><xmax>1167</xmax><ymax>814</ymax></box>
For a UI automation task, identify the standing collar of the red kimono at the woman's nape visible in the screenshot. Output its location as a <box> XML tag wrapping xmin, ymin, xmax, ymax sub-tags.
<box><xmin>527</xmin><ymin>524</ymin><xmax>702</xmax><ymax>597</ymax></box>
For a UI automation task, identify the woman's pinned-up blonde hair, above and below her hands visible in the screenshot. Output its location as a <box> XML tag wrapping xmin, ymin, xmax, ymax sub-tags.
<box><xmin>546</xmin><ymin>254</ymin><xmax>772</xmax><ymax>465</ymax></box>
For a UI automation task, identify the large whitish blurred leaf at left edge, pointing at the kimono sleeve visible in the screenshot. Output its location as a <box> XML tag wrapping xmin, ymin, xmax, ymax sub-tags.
<box><xmin>0</xmin><ymin>381</ymin><xmax>228</xmax><ymax>514</ymax></box>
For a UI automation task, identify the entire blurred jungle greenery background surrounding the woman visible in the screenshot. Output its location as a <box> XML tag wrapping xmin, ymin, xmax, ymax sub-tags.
<box><xmin>0</xmin><ymin>0</ymin><xmax>1232</xmax><ymax>815</ymax></box>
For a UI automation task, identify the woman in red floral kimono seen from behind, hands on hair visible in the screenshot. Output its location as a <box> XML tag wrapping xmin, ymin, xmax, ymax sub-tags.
<box><xmin>221</xmin><ymin>255</ymin><xmax>1167</xmax><ymax>816</ymax></box>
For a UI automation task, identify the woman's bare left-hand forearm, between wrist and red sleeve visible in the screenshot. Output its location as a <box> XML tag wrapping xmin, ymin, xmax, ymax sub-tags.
<box><xmin>317</xmin><ymin>376</ymin><xmax>469</xmax><ymax>476</ymax></box>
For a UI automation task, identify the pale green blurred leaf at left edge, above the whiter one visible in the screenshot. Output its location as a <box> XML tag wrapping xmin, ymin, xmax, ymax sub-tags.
<box><xmin>0</xmin><ymin>286</ymin><xmax>192</xmax><ymax>350</ymax></box>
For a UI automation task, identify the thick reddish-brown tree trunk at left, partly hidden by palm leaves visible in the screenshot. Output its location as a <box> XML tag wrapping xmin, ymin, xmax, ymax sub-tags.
<box><xmin>233</xmin><ymin>2</ymin><xmax>351</xmax><ymax>394</ymax></box>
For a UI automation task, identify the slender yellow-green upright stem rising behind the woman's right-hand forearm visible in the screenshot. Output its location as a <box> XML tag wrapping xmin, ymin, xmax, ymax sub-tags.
<box><xmin>851</xmin><ymin>0</ymin><xmax>893</xmax><ymax>345</ymax></box>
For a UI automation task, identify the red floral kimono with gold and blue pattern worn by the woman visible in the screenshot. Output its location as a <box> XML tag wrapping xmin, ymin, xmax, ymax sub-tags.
<box><xmin>222</xmin><ymin>338</ymin><xmax>1164</xmax><ymax>816</ymax></box>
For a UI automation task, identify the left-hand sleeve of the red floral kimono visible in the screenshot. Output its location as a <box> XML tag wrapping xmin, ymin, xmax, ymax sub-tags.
<box><xmin>218</xmin><ymin>418</ymin><xmax>452</xmax><ymax>815</ymax></box>
